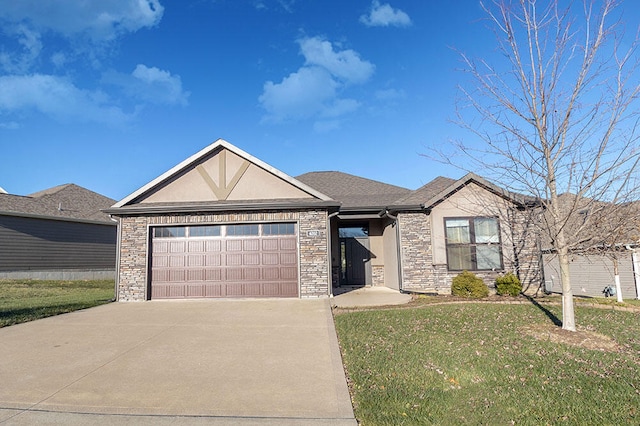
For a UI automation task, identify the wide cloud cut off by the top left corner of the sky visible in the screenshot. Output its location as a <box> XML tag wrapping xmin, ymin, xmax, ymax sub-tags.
<box><xmin>0</xmin><ymin>0</ymin><xmax>164</xmax><ymax>42</ymax></box>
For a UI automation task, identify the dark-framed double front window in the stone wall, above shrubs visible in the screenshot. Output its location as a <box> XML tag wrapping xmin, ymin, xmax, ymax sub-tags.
<box><xmin>444</xmin><ymin>217</ymin><xmax>502</xmax><ymax>271</ymax></box>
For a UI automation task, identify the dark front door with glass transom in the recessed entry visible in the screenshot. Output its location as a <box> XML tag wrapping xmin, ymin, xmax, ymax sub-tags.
<box><xmin>339</xmin><ymin>226</ymin><xmax>371</xmax><ymax>286</ymax></box>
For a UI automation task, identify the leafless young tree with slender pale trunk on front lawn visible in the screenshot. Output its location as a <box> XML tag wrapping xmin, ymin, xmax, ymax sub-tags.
<box><xmin>446</xmin><ymin>0</ymin><xmax>640</xmax><ymax>331</ymax></box>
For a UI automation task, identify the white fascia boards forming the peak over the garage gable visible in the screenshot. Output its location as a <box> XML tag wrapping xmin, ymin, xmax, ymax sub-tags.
<box><xmin>112</xmin><ymin>139</ymin><xmax>331</xmax><ymax>208</ymax></box>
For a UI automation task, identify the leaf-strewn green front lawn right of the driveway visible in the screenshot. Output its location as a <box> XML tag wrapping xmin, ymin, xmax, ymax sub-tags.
<box><xmin>335</xmin><ymin>303</ymin><xmax>640</xmax><ymax>425</ymax></box>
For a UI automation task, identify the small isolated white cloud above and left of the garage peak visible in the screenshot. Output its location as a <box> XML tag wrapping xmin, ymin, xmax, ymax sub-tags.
<box><xmin>102</xmin><ymin>64</ymin><xmax>190</xmax><ymax>106</ymax></box>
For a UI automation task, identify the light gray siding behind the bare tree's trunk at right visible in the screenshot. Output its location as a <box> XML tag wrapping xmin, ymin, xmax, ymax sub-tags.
<box><xmin>543</xmin><ymin>253</ymin><xmax>637</xmax><ymax>299</ymax></box>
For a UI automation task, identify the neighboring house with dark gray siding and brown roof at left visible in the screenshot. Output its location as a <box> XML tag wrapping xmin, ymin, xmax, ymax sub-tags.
<box><xmin>0</xmin><ymin>184</ymin><xmax>117</xmax><ymax>279</ymax></box>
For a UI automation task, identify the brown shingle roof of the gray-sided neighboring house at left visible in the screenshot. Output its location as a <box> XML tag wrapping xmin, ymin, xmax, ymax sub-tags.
<box><xmin>0</xmin><ymin>183</ymin><xmax>115</xmax><ymax>224</ymax></box>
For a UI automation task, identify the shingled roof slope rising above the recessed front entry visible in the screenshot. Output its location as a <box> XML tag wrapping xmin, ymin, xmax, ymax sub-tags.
<box><xmin>296</xmin><ymin>171</ymin><xmax>411</xmax><ymax>208</ymax></box>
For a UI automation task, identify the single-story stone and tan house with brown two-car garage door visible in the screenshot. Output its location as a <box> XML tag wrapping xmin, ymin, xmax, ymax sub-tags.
<box><xmin>105</xmin><ymin>140</ymin><xmax>542</xmax><ymax>301</ymax></box>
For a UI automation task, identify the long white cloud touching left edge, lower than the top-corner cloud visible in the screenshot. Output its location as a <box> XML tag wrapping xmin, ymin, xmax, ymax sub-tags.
<box><xmin>0</xmin><ymin>74</ymin><xmax>132</xmax><ymax>125</ymax></box>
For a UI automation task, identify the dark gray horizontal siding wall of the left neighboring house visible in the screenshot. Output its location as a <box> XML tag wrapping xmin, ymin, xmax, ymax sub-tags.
<box><xmin>0</xmin><ymin>216</ymin><xmax>116</xmax><ymax>271</ymax></box>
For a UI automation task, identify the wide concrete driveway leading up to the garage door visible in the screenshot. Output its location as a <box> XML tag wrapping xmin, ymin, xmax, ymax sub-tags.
<box><xmin>0</xmin><ymin>299</ymin><xmax>356</xmax><ymax>425</ymax></box>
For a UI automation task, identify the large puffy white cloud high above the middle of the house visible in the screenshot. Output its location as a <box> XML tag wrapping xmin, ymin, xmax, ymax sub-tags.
<box><xmin>258</xmin><ymin>37</ymin><xmax>375</xmax><ymax>128</ymax></box>
